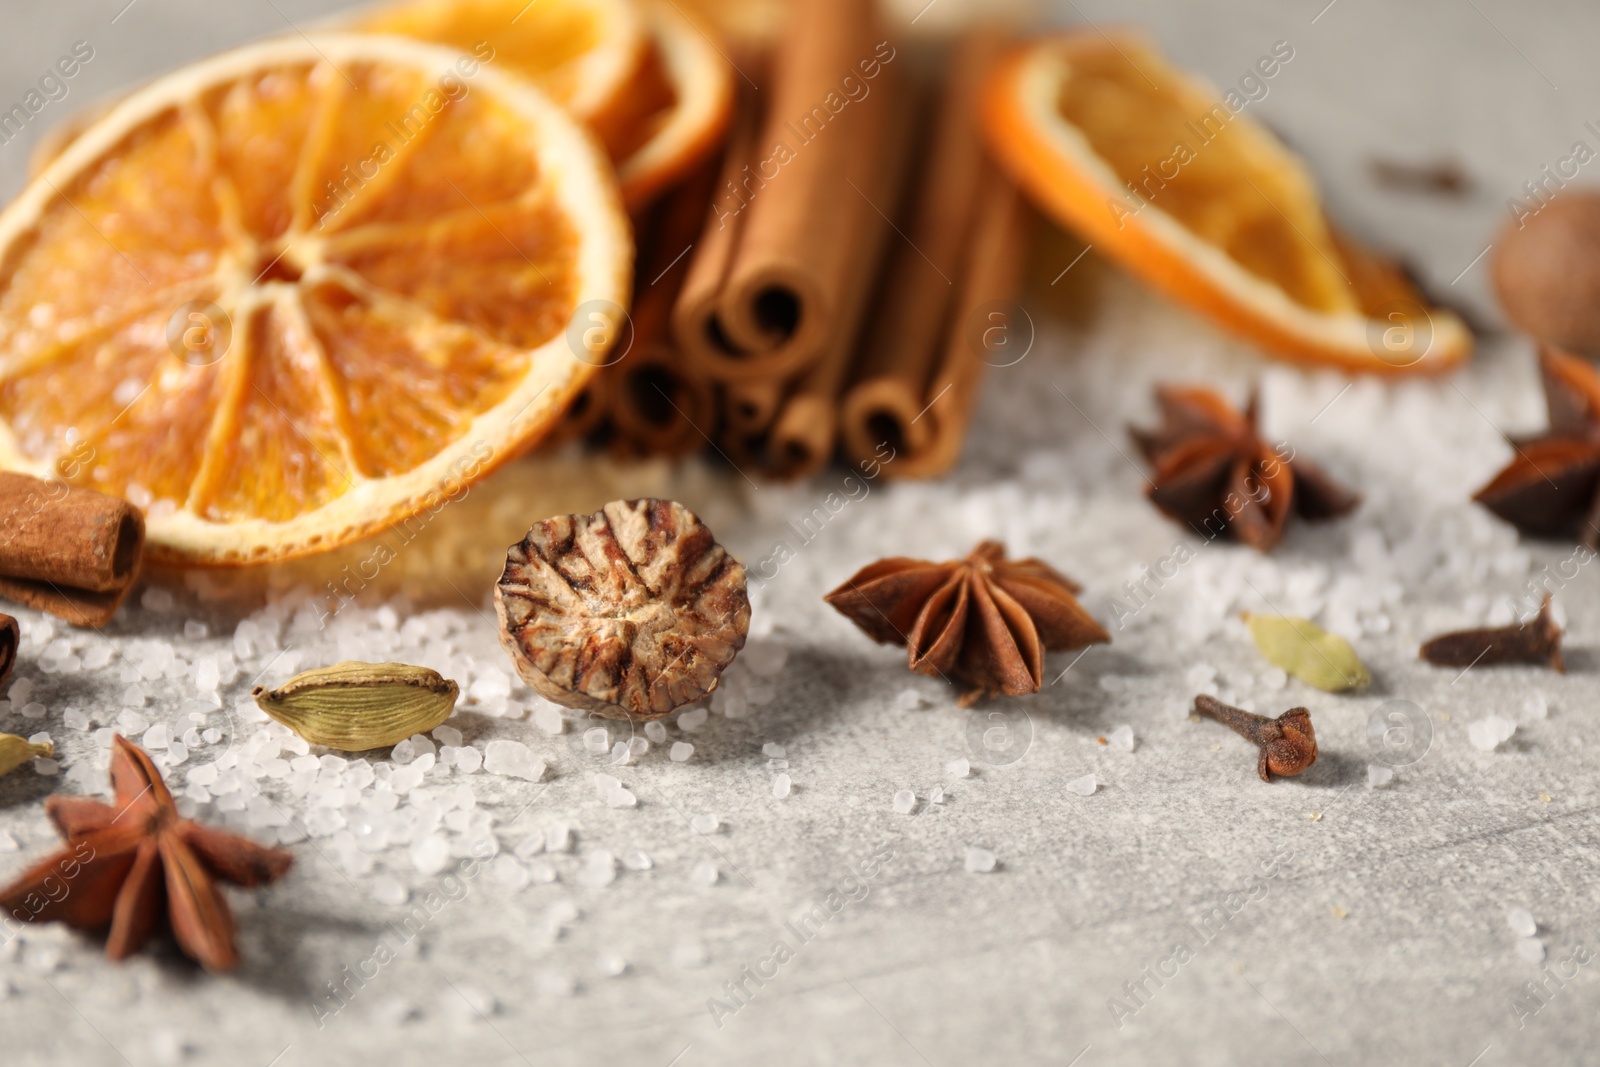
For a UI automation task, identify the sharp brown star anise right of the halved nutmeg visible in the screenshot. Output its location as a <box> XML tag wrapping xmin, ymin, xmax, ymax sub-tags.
<box><xmin>826</xmin><ymin>541</ymin><xmax>1110</xmax><ymax>707</ymax></box>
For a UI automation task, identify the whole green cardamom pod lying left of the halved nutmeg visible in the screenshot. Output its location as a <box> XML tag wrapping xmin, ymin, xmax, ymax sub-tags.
<box><xmin>250</xmin><ymin>662</ymin><xmax>461</xmax><ymax>752</ymax></box>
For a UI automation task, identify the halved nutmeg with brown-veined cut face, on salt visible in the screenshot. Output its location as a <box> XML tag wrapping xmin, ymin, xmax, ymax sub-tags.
<box><xmin>494</xmin><ymin>499</ymin><xmax>750</xmax><ymax>721</ymax></box>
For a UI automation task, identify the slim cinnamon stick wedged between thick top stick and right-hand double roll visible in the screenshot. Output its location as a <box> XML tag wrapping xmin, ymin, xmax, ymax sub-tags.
<box><xmin>766</xmin><ymin>69</ymin><xmax>910</xmax><ymax>478</ymax></box>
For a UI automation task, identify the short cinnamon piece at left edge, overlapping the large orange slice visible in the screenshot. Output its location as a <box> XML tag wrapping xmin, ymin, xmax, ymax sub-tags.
<box><xmin>0</xmin><ymin>472</ymin><xmax>144</xmax><ymax>627</ymax></box>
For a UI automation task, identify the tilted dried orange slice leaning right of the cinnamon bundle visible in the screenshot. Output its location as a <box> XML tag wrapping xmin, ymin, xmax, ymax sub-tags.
<box><xmin>984</xmin><ymin>32</ymin><xmax>1472</xmax><ymax>373</ymax></box>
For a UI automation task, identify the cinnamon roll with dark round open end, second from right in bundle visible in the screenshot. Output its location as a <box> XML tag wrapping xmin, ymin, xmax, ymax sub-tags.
<box><xmin>840</xmin><ymin>30</ymin><xmax>1003</xmax><ymax>461</ymax></box>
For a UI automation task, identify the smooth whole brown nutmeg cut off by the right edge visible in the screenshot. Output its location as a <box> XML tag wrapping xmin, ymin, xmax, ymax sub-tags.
<box><xmin>1494</xmin><ymin>190</ymin><xmax>1600</xmax><ymax>360</ymax></box>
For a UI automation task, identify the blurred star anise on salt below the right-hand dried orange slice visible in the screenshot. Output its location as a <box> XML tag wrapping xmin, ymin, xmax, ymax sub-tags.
<box><xmin>1130</xmin><ymin>386</ymin><xmax>1362</xmax><ymax>552</ymax></box>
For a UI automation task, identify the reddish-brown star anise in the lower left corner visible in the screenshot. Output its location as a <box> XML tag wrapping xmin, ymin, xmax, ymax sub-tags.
<box><xmin>0</xmin><ymin>737</ymin><xmax>294</xmax><ymax>971</ymax></box>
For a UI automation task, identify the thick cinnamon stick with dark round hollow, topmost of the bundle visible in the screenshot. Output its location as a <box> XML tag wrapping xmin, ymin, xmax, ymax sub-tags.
<box><xmin>717</xmin><ymin>0</ymin><xmax>898</xmax><ymax>378</ymax></box>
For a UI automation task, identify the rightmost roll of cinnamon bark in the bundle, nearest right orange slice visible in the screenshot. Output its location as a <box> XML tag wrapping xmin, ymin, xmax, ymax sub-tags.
<box><xmin>889</xmin><ymin>163</ymin><xmax>1032</xmax><ymax>478</ymax></box>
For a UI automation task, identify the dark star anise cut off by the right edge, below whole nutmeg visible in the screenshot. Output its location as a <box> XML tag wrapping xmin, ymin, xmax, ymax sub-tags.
<box><xmin>1472</xmin><ymin>347</ymin><xmax>1600</xmax><ymax>549</ymax></box>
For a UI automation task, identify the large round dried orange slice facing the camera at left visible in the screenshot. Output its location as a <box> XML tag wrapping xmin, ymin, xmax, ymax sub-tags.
<box><xmin>0</xmin><ymin>35</ymin><xmax>632</xmax><ymax>565</ymax></box>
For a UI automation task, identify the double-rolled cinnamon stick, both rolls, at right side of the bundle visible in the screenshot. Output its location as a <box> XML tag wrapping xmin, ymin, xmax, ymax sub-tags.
<box><xmin>842</xmin><ymin>30</ymin><xmax>1022</xmax><ymax>477</ymax></box>
